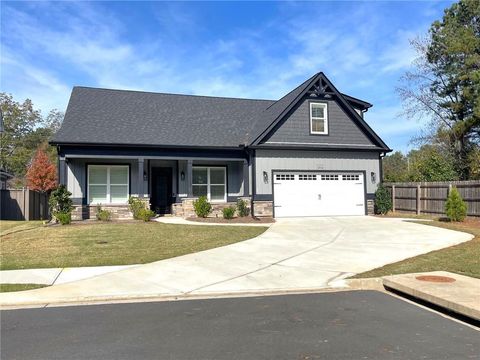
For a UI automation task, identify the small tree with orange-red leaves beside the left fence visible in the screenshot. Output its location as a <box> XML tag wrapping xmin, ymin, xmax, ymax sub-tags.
<box><xmin>26</xmin><ymin>148</ymin><xmax>57</xmax><ymax>192</ymax></box>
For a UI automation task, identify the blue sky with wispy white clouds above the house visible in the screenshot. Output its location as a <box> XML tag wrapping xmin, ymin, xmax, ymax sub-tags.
<box><xmin>0</xmin><ymin>1</ymin><xmax>451</xmax><ymax>151</ymax></box>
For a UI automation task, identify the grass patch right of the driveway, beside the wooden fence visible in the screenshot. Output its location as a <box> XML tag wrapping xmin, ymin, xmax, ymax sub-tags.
<box><xmin>353</xmin><ymin>217</ymin><xmax>480</xmax><ymax>278</ymax></box>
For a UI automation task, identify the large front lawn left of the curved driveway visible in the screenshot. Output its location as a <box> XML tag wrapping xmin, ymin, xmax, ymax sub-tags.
<box><xmin>0</xmin><ymin>221</ymin><xmax>267</xmax><ymax>270</ymax></box>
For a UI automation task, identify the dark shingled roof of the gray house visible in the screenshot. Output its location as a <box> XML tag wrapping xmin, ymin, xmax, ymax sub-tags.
<box><xmin>51</xmin><ymin>73</ymin><xmax>388</xmax><ymax>149</ymax></box>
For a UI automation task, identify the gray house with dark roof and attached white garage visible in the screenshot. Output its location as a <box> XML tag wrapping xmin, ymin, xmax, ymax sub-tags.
<box><xmin>51</xmin><ymin>72</ymin><xmax>391</xmax><ymax>219</ymax></box>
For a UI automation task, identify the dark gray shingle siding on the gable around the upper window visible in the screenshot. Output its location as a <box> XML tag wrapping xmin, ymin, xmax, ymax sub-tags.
<box><xmin>266</xmin><ymin>99</ymin><xmax>375</xmax><ymax>148</ymax></box>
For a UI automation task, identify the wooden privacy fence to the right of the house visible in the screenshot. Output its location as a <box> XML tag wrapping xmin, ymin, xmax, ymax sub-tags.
<box><xmin>384</xmin><ymin>180</ymin><xmax>480</xmax><ymax>216</ymax></box>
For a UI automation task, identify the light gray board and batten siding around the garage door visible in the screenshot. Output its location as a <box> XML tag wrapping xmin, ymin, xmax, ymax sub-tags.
<box><xmin>255</xmin><ymin>150</ymin><xmax>380</xmax><ymax>195</ymax></box>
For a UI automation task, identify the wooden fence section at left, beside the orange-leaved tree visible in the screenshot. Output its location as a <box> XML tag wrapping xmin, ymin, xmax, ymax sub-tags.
<box><xmin>0</xmin><ymin>188</ymin><xmax>49</xmax><ymax>220</ymax></box>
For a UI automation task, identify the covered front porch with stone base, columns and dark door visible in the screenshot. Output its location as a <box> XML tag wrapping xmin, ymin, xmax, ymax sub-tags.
<box><xmin>59</xmin><ymin>146</ymin><xmax>251</xmax><ymax>220</ymax></box>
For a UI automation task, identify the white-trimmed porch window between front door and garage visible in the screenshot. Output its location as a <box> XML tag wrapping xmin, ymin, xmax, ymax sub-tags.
<box><xmin>192</xmin><ymin>166</ymin><xmax>227</xmax><ymax>202</ymax></box>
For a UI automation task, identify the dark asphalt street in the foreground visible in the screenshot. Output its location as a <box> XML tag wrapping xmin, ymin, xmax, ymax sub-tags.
<box><xmin>1</xmin><ymin>291</ymin><xmax>480</xmax><ymax>360</ymax></box>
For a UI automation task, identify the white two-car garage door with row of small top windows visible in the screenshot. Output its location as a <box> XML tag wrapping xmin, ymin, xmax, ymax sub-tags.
<box><xmin>273</xmin><ymin>172</ymin><xmax>365</xmax><ymax>217</ymax></box>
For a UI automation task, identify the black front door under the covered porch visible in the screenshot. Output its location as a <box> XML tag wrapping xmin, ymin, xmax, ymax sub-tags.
<box><xmin>150</xmin><ymin>167</ymin><xmax>172</xmax><ymax>214</ymax></box>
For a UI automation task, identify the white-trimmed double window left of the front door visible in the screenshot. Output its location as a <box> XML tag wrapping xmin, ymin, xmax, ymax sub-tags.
<box><xmin>87</xmin><ymin>165</ymin><xmax>129</xmax><ymax>204</ymax></box>
